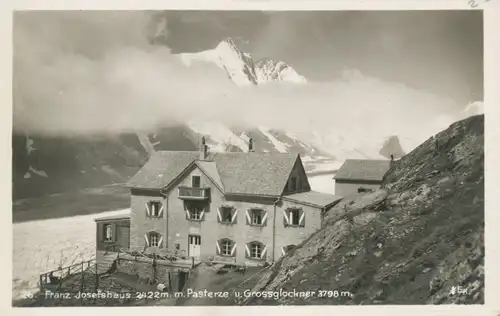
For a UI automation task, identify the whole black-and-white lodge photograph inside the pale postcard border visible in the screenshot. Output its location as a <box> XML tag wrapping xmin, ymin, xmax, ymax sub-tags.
<box><xmin>9</xmin><ymin>7</ymin><xmax>490</xmax><ymax>312</ymax></box>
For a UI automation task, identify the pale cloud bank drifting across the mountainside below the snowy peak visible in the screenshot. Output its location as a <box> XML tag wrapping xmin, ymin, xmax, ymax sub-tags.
<box><xmin>14</xmin><ymin>11</ymin><xmax>462</xmax><ymax>155</ymax></box>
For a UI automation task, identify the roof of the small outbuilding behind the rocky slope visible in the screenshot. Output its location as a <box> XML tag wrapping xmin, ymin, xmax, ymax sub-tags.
<box><xmin>333</xmin><ymin>159</ymin><xmax>390</xmax><ymax>181</ymax></box>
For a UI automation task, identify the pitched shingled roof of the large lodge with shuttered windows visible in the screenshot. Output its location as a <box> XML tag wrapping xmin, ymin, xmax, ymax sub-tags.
<box><xmin>128</xmin><ymin>151</ymin><xmax>298</xmax><ymax>196</ymax></box>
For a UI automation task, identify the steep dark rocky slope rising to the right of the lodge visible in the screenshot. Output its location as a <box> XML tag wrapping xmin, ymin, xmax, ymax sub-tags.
<box><xmin>239</xmin><ymin>115</ymin><xmax>484</xmax><ymax>305</ymax></box>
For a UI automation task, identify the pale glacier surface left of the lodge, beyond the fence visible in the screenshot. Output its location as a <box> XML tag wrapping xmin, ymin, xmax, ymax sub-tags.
<box><xmin>12</xmin><ymin>209</ymin><xmax>130</xmax><ymax>299</ymax></box>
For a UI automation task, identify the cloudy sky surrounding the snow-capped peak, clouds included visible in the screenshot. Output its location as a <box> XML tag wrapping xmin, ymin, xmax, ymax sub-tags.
<box><xmin>13</xmin><ymin>11</ymin><xmax>483</xmax><ymax>153</ymax></box>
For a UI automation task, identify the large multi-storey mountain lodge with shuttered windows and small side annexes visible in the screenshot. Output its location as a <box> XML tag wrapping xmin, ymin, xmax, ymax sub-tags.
<box><xmin>96</xmin><ymin>139</ymin><xmax>340</xmax><ymax>265</ymax></box>
